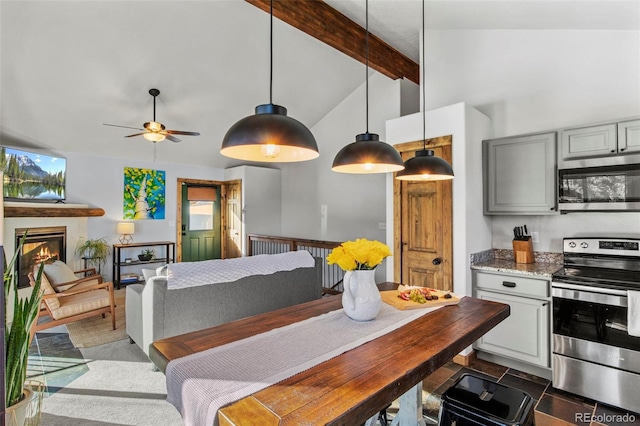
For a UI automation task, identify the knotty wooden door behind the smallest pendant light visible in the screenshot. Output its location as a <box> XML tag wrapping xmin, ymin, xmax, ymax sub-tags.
<box><xmin>394</xmin><ymin>136</ymin><xmax>455</xmax><ymax>291</ymax></box>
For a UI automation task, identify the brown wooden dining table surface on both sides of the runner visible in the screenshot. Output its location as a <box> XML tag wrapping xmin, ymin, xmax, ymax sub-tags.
<box><xmin>149</xmin><ymin>283</ymin><xmax>509</xmax><ymax>425</ymax></box>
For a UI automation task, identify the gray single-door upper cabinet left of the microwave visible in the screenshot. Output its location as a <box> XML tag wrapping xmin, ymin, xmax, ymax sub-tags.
<box><xmin>482</xmin><ymin>132</ymin><xmax>557</xmax><ymax>215</ymax></box>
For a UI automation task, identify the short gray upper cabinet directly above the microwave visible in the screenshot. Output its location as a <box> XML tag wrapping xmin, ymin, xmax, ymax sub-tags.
<box><xmin>561</xmin><ymin>120</ymin><xmax>640</xmax><ymax>160</ymax></box>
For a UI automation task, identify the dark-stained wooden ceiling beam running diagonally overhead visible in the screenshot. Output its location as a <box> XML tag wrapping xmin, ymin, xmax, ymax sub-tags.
<box><xmin>245</xmin><ymin>0</ymin><xmax>420</xmax><ymax>84</ymax></box>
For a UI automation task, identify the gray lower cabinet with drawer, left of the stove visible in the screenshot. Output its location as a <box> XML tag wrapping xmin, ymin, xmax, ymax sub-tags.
<box><xmin>473</xmin><ymin>271</ymin><xmax>550</xmax><ymax>368</ymax></box>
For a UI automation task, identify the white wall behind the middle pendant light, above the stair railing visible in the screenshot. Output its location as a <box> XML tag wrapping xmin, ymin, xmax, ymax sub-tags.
<box><xmin>282</xmin><ymin>72</ymin><xmax>417</xmax><ymax>282</ymax></box>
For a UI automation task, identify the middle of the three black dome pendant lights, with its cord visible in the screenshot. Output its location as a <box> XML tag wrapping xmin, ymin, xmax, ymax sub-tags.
<box><xmin>331</xmin><ymin>0</ymin><xmax>404</xmax><ymax>173</ymax></box>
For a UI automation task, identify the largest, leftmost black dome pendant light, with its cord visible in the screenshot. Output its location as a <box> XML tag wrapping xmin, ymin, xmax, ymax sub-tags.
<box><xmin>220</xmin><ymin>0</ymin><xmax>320</xmax><ymax>163</ymax></box>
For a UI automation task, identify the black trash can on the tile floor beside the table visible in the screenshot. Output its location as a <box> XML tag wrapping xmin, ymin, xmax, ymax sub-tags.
<box><xmin>438</xmin><ymin>374</ymin><xmax>534</xmax><ymax>426</ymax></box>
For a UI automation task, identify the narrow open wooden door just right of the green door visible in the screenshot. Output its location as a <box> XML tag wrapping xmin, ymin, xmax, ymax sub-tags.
<box><xmin>222</xmin><ymin>180</ymin><xmax>242</xmax><ymax>259</ymax></box>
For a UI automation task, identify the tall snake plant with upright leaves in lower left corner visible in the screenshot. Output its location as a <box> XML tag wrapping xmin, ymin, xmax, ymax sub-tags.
<box><xmin>3</xmin><ymin>233</ymin><xmax>44</xmax><ymax>426</ymax></box>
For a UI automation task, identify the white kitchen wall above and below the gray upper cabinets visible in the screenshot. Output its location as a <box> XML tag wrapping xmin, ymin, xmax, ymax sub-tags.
<box><xmin>426</xmin><ymin>30</ymin><xmax>640</xmax><ymax>252</ymax></box>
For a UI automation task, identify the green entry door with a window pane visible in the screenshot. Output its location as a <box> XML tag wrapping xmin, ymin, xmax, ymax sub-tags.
<box><xmin>182</xmin><ymin>184</ymin><xmax>222</xmax><ymax>262</ymax></box>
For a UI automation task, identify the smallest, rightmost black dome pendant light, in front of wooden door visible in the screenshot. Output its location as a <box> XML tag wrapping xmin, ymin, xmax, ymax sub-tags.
<box><xmin>396</xmin><ymin>0</ymin><xmax>453</xmax><ymax>180</ymax></box>
